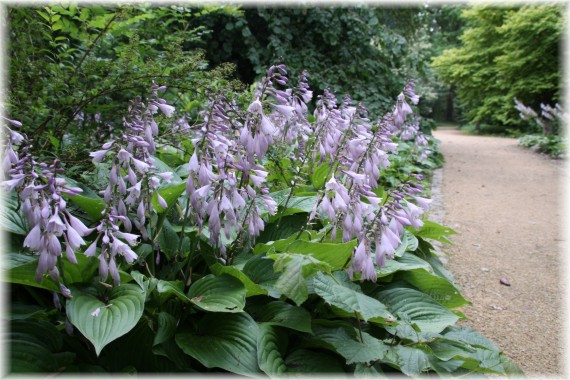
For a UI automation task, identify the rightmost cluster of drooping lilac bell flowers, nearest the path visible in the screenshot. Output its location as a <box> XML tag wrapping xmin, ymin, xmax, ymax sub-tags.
<box><xmin>302</xmin><ymin>83</ymin><xmax>429</xmax><ymax>281</ymax></box>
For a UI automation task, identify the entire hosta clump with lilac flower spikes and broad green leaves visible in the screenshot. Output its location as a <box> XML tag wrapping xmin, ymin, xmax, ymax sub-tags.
<box><xmin>2</xmin><ymin>64</ymin><xmax>519</xmax><ymax>376</ymax></box>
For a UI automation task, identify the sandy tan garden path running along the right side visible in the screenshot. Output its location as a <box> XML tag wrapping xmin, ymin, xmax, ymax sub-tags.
<box><xmin>434</xmin><ymin>127</ymin><xmax>568</xmax><ymax>377</ymax></box>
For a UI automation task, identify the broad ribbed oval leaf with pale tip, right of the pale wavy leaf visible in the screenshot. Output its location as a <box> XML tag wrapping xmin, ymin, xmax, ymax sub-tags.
<box><xmin>374</xmin><ymin>287</ymin><xmax>459</xmax><ymax>333</ymax></box>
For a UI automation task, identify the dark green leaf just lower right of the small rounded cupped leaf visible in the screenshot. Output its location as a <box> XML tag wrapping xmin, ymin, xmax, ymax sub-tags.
<box><xmin>248</xmin><ymin>301</ymin><xmax>312</xmax><ymax>334</ymax></box>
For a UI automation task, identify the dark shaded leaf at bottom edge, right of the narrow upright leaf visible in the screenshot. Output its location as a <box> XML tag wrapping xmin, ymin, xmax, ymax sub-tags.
<box><xmin>285</xmin><ymin>349</ymin><xmax>345</xmax><ymax>376</ymax></box>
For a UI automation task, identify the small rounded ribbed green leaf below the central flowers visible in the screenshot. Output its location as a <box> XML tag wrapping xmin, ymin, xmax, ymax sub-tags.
<box><xmin>187</xmin><ymin>274</ymin><xmax>247</xmax><ymax>313</ymax></box>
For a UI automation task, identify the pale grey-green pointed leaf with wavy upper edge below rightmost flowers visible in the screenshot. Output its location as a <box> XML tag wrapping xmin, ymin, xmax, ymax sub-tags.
<box><xmin>313</xmin><ymin>272</ymin><xmax>396</xmax><ymax>322</ymax></box>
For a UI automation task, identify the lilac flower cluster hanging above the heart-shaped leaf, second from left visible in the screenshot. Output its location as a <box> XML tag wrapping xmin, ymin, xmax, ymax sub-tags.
<box><xmin>85</xmin><ymin>83</ymin><xmax>174</xmax><ymax>285</ymax></box>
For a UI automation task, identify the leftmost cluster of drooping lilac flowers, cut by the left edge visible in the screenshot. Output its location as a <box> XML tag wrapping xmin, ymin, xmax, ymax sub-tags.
<box><xmin>3</xmin><ymin>118</ymin><xmax>93</xmax><ymax>297</ymax></box>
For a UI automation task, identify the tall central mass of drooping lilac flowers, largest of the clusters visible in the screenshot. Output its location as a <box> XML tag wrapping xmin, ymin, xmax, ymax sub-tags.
<box><xmin>185</xmin><ymin>65</ymin><xmax>295</xmax><ymax>259</ymax></box>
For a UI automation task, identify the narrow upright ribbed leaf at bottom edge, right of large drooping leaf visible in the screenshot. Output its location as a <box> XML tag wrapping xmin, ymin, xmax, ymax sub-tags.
<box><xmin>257</xmin><ymin>323</ymin><xmax>287</xmax><ymax>376</ymax></box>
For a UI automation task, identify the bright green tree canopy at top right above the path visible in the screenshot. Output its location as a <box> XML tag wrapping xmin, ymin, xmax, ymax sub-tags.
<box><xmin>433</xmin><ymin>5</ymin><xmax>564</xmax><ymax>132</ymax></box>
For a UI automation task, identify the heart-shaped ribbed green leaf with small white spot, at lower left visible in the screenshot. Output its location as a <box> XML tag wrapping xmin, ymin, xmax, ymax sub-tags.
<box><xmin>66</xmin><ymin>284</ymin><xmax>146</xmax><ymax>356</ymax></box>
